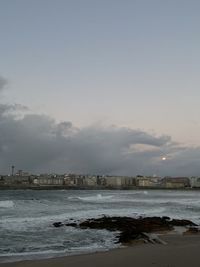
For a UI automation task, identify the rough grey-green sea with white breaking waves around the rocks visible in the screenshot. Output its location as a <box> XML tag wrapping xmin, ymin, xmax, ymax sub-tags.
<box><xmin>0</xmin><ymin>190</ymin><xmax>200</xmax><ymax>263</ymax></box>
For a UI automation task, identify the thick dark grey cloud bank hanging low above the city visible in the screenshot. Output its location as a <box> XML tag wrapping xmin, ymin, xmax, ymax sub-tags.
<box><xmin>0</xmin><ymin>77</ymin><xmax>200</xmax><ymax>176</ymax></box>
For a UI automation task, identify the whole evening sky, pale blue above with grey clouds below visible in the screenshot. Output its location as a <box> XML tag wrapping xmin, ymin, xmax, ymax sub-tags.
<box><xmin>0</xmin><ymin>0</ymin><xmax>200</xmax><ymax>176</ymax></box>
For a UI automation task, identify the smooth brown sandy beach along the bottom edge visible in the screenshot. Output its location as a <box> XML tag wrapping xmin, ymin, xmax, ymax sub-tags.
<box><xmin>0</xmin><ymin>234</ymin><xmax>200</xmax><ymax>267</ymax></box>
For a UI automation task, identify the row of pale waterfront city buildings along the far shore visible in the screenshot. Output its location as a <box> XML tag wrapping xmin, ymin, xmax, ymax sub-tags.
<box><xmin>0</xmin><ymin>174</ymin><xmax>200</xmax><ymax>189</ymax></box>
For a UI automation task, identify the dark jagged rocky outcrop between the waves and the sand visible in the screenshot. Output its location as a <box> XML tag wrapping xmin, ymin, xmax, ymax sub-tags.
<box><xmin>54</xmin><ymin>216</ymin><xmax>196</xmax><ymax>246</ymax></box>
